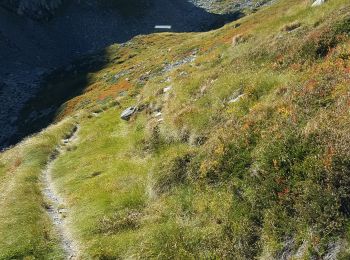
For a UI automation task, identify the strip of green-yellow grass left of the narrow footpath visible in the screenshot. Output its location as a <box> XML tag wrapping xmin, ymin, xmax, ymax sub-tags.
<box><xmin>0</xmin><ymin>120</ymin><xmax>73</xmax><ymax>259</ymax></box>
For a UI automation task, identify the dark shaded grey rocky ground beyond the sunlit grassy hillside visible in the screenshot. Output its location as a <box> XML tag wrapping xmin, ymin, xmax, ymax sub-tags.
<box><xmin>0</xmin><ymin>0</ymin><xmax>243</xmax><ymax>149</ymax></box>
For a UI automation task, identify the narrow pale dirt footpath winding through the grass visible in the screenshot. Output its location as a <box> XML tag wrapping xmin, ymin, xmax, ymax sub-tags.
<box><xmin>42</xmin><ymin>126</ymin><xmax>79</xmax><ymax>259</ymax></box>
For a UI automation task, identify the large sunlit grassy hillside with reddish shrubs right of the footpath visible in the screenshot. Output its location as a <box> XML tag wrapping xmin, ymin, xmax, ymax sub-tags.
<box><xmin>0</xmin><ymin>0</ymin><xmax>350</xmax><ymax>259</ymax></box>
